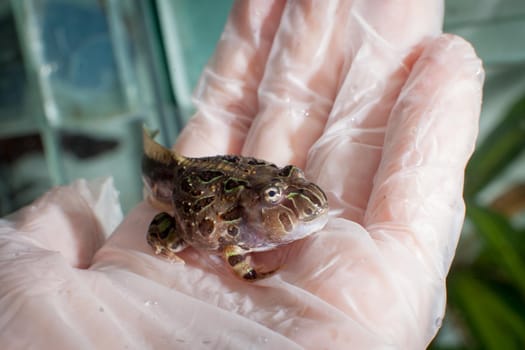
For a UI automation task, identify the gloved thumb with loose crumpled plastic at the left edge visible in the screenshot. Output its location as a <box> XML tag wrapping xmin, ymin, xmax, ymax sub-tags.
<box><xmin>0</xmin><ymin>179</ymin><xmax>118</xmax><ymax>268</ymax></box>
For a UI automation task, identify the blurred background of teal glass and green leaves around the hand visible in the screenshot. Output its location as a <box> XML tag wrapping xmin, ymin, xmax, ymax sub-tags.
<box><xmin>0</xmin><ymin>0</ymin><xmax>525</xmax><ymax>349</ymax></box>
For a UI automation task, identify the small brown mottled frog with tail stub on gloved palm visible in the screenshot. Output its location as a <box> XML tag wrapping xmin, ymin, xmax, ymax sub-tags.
<box><xmin>142</xmin><ymin>130</ymin><xmax>328</xmax><ymax>281</ymax></box>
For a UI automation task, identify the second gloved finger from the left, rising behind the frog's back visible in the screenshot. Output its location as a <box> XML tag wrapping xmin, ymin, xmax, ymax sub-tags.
<box><xmin>243</xmin><ymin>0</ymin><xmax>352</xmax><ymax>166</ymax></box>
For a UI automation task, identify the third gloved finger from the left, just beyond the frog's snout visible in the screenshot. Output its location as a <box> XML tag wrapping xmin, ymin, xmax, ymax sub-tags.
<box><xmin>307</xmin><ymin>0</ymin><xmax>443</xmax><ymax>223</ymax></box>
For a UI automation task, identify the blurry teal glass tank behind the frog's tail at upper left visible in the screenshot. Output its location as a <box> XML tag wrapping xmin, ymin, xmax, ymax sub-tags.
<box><xmin>0</xmin><ymin>0</ymin><xmax>181</xmax><ymax>214</ymax></box>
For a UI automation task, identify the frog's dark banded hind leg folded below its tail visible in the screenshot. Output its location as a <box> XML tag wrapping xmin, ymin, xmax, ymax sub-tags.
<box><xmin>146</xmin><ymin>212</ymin><xmax>187</xmax><ymax>263</ymax></box>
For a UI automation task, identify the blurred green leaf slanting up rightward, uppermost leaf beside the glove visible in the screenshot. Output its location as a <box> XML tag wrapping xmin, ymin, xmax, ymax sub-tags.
<box><xmin>465</xmin><ymin>96</ymin><xmax>525</xmax><ymax>197</ymax></box>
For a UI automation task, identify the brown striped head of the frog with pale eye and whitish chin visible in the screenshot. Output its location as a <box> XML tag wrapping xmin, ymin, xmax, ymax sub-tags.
<box><xmin>238</xmin><ymin>165</ymin><xmax>328</xmax><ymax>248</ymax></box>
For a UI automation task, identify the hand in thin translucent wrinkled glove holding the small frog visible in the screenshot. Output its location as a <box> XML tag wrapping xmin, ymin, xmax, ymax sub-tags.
<box><xmin>0</xmin><ymin>0</ymin><xmax>483</xmax><ymax>349</ymax></box>
